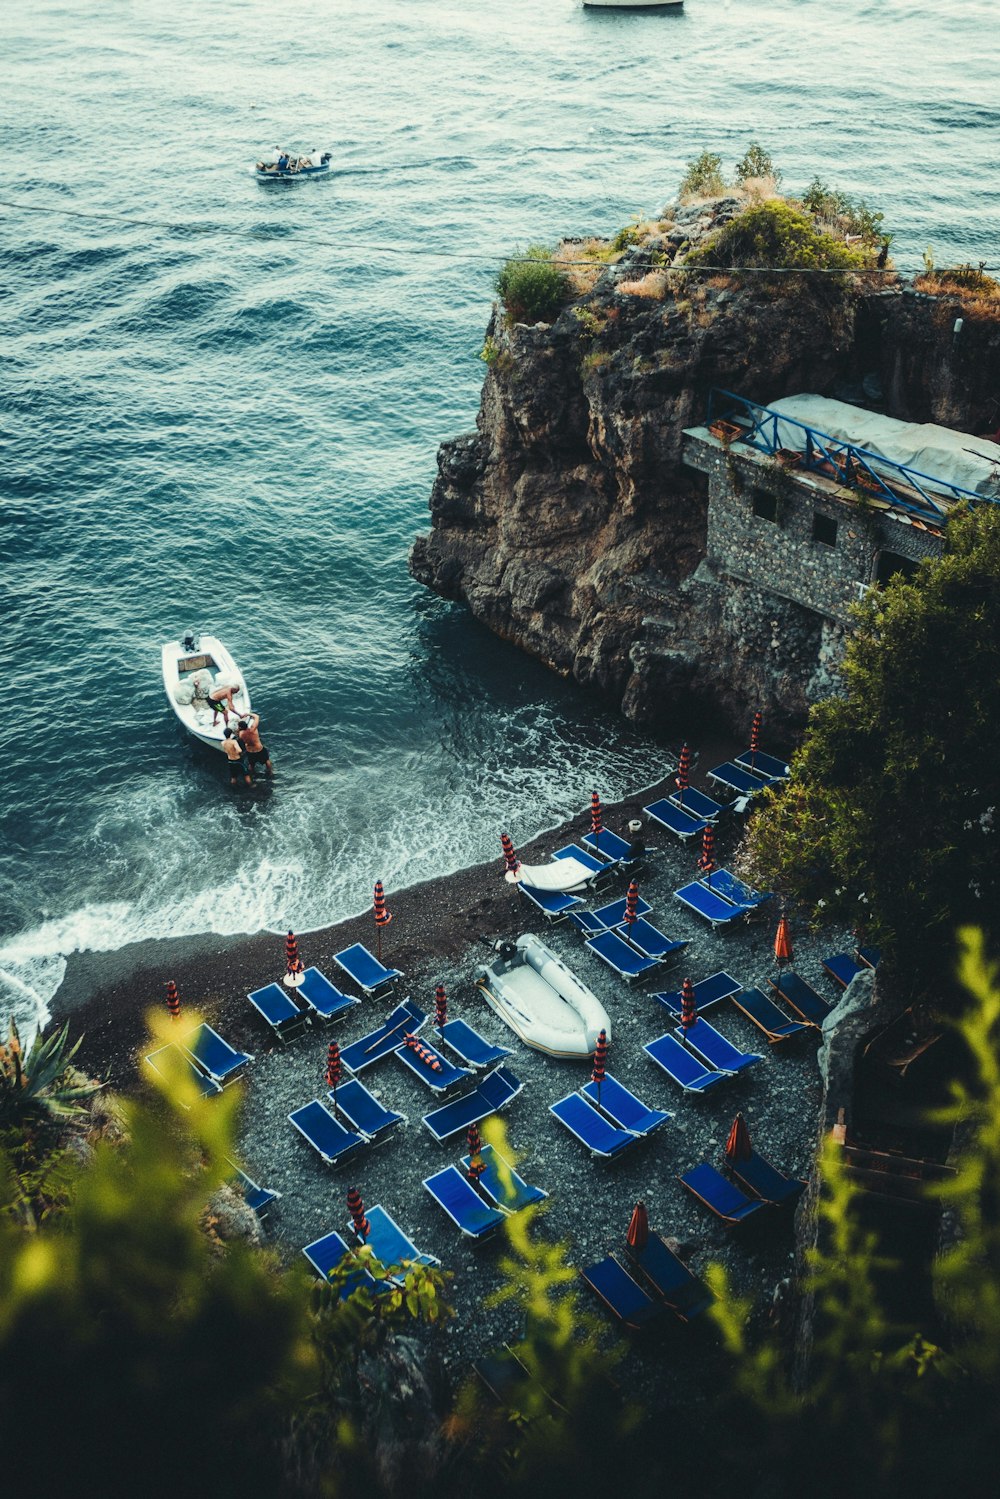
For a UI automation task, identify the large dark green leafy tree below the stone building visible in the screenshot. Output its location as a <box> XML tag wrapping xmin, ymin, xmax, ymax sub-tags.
<box><xmin>748</xmin><ymin>504</ymin><xmax>1000</xmax><ymax>995</ymax></box>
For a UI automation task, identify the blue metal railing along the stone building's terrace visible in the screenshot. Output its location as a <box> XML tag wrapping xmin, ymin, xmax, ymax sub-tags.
<box><xmin>708</xmin><ymin>388</ymin><xmax>997</xmax><ymax>523</ymax></box>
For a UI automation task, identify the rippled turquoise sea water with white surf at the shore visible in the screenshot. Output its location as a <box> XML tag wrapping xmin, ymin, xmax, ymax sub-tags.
<box><xmin>0</xmin><ymin>0</ymin><xmax>1000</xmax><ymax>1019</ymax></box>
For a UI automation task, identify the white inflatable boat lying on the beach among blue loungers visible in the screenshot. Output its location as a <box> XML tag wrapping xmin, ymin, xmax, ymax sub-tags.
<box><xmin>475</xmin><ymin>932</ymin><xmax>612</xmax><ymax>1058</ymax></box>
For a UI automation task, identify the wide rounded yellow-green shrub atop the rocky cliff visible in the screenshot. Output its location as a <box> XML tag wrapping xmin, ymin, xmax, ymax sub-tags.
<box><xmin>685</xmin><ymin>199</ymin><xmax>870</xmax><ymax>270</ymax></box>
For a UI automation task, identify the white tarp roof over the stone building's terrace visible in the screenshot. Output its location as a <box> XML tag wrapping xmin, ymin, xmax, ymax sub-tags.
<box><xmin>768</xmin><ymin>396</ymin><xmax>1000</xmax><ymax>499</ymax></box>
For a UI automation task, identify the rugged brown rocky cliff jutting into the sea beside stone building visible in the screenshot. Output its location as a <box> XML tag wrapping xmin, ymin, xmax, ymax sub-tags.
<box><xmin>411</xmin><ymin>198</ymin><xmax>1000</xmax><ymax>730</ymax></box>
